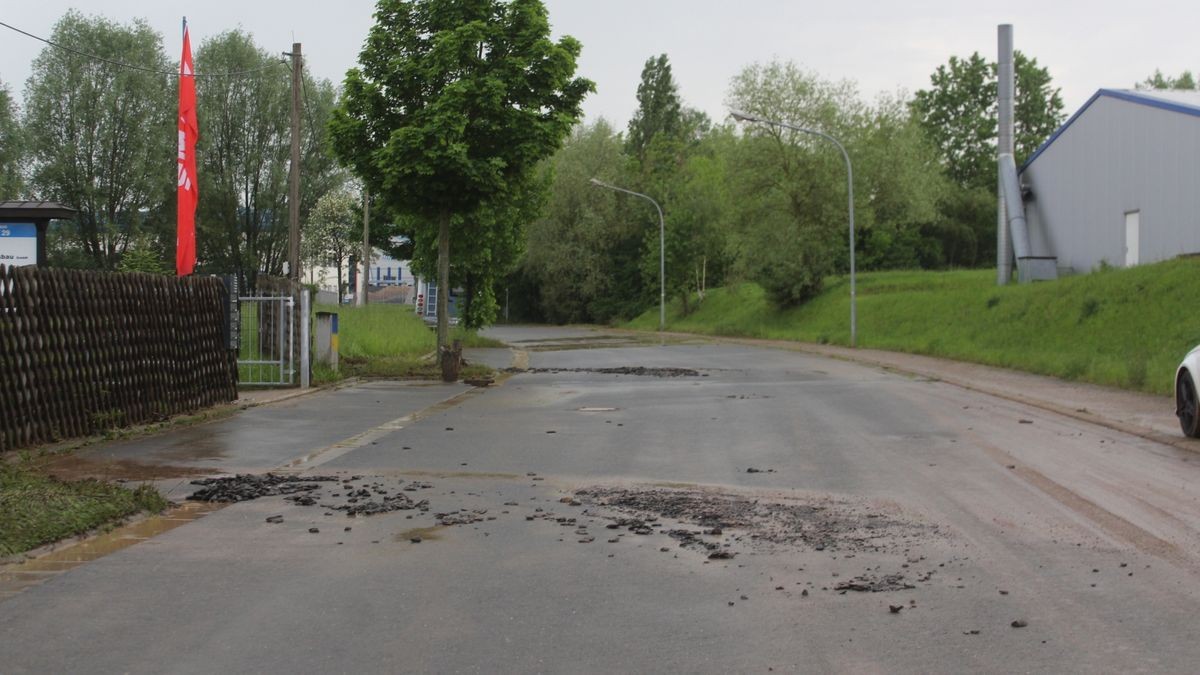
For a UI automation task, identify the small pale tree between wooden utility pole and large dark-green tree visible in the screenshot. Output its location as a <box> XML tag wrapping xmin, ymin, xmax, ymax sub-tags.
<box><xmin>300</xmin><ymin>189</ymin><xmax>362</xmax><ymax>298</ymax></box>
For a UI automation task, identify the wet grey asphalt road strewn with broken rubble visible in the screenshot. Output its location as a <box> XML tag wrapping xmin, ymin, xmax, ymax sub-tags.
<box><xmin>0</xmin><ymin>329</ymin><xmax>1200</xmax><ymax>673</ymax></box>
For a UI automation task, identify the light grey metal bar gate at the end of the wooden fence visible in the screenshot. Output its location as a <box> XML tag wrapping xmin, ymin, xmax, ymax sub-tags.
<box><xmin>238</xmin><ymin>295</ymin><xmax>296</xmax><ymax>387</ymax></box>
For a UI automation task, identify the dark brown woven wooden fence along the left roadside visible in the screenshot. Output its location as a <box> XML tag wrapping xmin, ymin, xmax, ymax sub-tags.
<box><xmin>0</xmin><ymin>265</ymin><xmax>238</xmax><ymax>452</ymax></box>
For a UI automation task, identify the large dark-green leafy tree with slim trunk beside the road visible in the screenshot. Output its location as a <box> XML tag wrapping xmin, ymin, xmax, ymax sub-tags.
<box><xmin>330</xmin><ymin>0</ymin><xmax>594</xmax><ymax>347</ymax></box>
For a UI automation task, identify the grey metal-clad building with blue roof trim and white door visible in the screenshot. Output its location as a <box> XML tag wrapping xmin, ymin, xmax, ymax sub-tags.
<box><xmin>1021</xmin><ymin>89</ymin><xmax>1200</xmax><ymax>274</ymax></box>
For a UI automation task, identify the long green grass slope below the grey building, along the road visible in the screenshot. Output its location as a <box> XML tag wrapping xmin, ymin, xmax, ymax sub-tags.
<box><xmin>629</xmin><ymin>258</ymin><xmax>1200</xmax><ymax>394</ymax></box>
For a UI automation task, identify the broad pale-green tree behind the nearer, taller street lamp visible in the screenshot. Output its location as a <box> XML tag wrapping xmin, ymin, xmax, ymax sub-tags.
<box><xmin>728</xmin><ymin>61</ymin><xmax>948</xmax><ymax>306</ymax></box>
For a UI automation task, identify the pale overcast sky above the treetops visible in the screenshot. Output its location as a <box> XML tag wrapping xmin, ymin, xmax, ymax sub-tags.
<box><xmin>0</xmin><ymin>0</ymin><xmax>1200</xmax><ymax>126</ymax></box>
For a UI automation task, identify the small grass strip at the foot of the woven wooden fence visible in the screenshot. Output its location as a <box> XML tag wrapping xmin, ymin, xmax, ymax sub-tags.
<box><xmin>0</xmin><ymin>460</ymin><xmax>168</xmax><ymax>557</ymax></box>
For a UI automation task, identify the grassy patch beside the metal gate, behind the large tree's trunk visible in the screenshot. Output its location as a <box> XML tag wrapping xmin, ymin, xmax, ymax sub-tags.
<box><xmin>314</xmin><ymin>304</ymin><xmax>504</xmax><ymax>382</ymax></box>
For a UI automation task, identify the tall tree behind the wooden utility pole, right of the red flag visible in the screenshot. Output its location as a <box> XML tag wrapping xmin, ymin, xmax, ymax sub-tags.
<box><xmin>196</xmin><ymin>30</ymin><xmax>344</xmax><ymax>287</ymax></box>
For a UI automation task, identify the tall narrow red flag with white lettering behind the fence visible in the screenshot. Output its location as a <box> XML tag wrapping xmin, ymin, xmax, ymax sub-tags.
<box><xmin>175</xmin><ymin>19</ymin><xmax>200</xmax><ymax>276</ymax></box>
